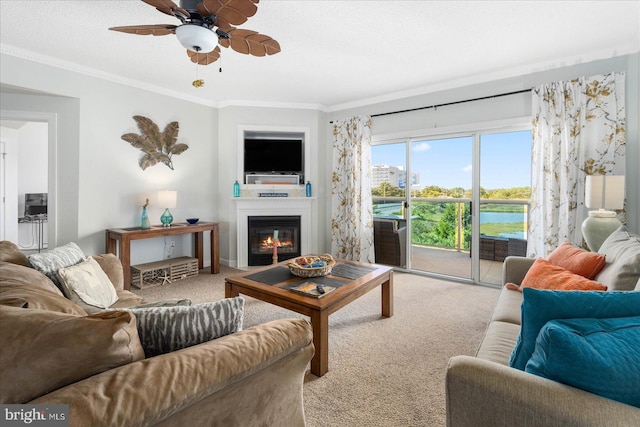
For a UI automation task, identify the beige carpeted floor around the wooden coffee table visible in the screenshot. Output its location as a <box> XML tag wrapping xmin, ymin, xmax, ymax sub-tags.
<box><xmin>132</xmin><ymin>266</ymin><xmax>498</xmax><ymax>427</ymax></box>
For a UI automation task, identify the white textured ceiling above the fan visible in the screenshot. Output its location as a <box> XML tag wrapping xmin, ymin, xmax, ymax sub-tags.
<box><xmin>0</xmin><ymin>0</ymin><xmax>640</xmax><ymax>110</ymax></box>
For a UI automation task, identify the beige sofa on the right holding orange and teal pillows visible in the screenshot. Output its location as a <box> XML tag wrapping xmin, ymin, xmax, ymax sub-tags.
<box><xmin>446</xmin><ymin>227</ymin><xmax>640</xmax><ymax>427</ymax></box>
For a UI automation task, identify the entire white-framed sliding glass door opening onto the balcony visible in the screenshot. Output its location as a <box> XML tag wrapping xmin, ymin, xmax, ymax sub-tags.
<box><xmin>372</xmin><ymin>129</ymin><xmax>531</xmax><ymax>284</ymax></box>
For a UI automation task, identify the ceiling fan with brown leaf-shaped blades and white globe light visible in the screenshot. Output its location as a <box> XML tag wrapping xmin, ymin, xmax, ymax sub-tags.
<box><xmin>109</xmin><ymin>0</ymin><xmax>280</xmax><ymax>65</ymax></box>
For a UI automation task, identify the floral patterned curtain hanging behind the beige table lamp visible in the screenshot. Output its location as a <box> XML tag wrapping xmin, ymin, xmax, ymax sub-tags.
<box><xmin>528</xmin><ymin>73</ymin><xmax>625</xmax><ymax>257</ymax></box>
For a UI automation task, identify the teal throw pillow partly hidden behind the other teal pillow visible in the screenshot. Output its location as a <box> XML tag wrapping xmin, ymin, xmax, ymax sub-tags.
<box><xmin>509</xmin><ymin>288</ymin><xmax>640</xmax><ymax>371</ymax></box>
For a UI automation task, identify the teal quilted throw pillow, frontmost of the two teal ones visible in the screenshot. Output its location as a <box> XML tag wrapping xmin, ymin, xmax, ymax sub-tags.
<box><xmin>525</xmin><ymin>317</ymin><xmax>640</xmax><ymax>407</ymax></box>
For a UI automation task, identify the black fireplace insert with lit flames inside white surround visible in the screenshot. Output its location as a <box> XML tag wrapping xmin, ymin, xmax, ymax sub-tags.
<box><xmin>247</xmin><ymin>216</ymin><xmax>301</xmax><ymax>265</ymax></box>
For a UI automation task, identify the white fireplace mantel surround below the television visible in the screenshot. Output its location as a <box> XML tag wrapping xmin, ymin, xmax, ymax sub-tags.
<box><xmin>232</xmin><ymin>197</ymin><xmax>318</xmax><ymax>268</ymax></box>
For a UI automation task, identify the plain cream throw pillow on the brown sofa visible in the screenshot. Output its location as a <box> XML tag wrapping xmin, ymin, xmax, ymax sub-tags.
<box><xmin>58</xmin><ymin>256</ymin><xmax>118</xmax><ymax>308</ymax></box>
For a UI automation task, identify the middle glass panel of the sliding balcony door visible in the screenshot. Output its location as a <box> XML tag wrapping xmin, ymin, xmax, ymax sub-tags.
<box><xmin>409</xmin><ymin>136</ymin><xmax>473</xmax><ymax>279</ymax></box>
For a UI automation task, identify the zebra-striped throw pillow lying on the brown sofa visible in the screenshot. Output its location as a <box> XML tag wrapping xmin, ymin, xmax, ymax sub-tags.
<box><xmin>124</xmin><ymin>297</ymin><xmax>244</xmax><ymax>357</ymax></box>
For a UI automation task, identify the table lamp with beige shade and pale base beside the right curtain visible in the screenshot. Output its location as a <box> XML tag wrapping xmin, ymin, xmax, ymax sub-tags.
<box><xmin>582</xmin><ymin>175</ymin><xmax>624</xmax><ymax>252</ymax></box>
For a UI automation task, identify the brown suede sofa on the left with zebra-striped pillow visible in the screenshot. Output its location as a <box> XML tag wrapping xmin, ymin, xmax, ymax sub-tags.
<box><xmin>0</xmin><ymin>242</ymin><xmax>314</xmax><ymax>427</ymax></box>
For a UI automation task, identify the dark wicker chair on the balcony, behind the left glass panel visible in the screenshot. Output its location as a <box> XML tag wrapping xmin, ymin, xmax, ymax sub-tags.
<box><xmin>373</xmin><ymin>218</ymin><xmax>407</xmax><ymax>267</ymax></box>
